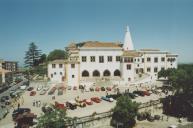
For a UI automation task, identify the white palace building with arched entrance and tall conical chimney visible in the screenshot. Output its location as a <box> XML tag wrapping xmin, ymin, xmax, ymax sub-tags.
<box><xmin>48</xmin><ymin>27</ymin><xmax>178</xmax><ymax>86</ymax></box>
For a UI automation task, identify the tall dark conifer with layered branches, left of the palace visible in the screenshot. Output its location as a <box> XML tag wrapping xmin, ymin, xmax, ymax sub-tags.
<box><xmin>24</xmin><ymin>42</ymin><xmax>41</xmax><ymax>68</ymax></box>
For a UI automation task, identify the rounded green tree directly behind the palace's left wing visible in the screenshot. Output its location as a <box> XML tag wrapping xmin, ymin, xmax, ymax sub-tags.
<box><xmin>47</xmin><ymin>49</ymin><xmax>68</xmax><ymax>61</ymax></box>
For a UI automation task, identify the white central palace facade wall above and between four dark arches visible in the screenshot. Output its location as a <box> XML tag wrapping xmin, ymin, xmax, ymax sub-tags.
<box><xmin>79</xmin><ymin>49</ymin><xmax>122</xmax><ymax>77</ymax></box>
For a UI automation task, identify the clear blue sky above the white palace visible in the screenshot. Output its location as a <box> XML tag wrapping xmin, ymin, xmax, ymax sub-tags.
<box><xmin>0</xmin><ymin>0</ymin><xmax>193</xmax><ymax>65</ymax></box>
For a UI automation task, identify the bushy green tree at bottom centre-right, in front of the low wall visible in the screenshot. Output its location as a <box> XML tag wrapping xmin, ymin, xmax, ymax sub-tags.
<box><xmin>111</xmin><ymin>96</ymin><xmax>139</xmax><ymax>128</ymax></box>
